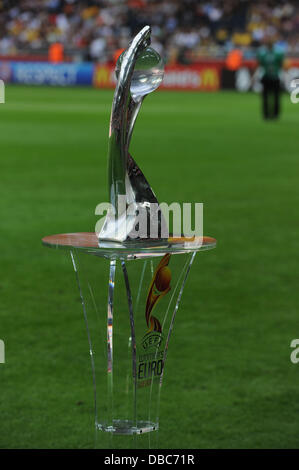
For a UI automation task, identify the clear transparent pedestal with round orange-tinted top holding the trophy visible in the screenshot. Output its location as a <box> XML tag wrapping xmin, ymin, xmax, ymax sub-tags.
<box><xmin>43</xmin><ymin>233</ymin><xmax>216</xmax><ymax>449</ymax></box>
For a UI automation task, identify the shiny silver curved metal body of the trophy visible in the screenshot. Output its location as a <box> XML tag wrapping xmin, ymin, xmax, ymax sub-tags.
<box><xmin>98</xmin><ymin>26</ymin><xmax>163</xmax><ymax>243</ymax></box>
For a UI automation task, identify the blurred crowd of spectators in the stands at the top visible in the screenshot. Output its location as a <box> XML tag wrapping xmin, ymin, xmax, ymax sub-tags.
<box><xmin>0</xmin><ymin>0</ymin><xmax>299</xmax><ymax>64</ymax></box>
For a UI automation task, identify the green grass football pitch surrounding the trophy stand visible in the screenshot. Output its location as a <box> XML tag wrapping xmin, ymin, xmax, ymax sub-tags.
<box><xmin>0</xmin><ymin>86</ymin><xmax>299</xmax><ymax>449</ymax></box>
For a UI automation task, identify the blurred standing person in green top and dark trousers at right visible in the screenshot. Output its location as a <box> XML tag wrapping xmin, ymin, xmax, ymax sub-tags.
<box><xmin>257</xmin><ymin>39</ymin><xmax>284</xmax><ymax>119</ymax></box>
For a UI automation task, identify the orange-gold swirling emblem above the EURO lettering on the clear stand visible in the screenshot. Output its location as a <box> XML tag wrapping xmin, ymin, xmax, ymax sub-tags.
<box><xmin>145</xmin><ymin>254</ymin><xmax>171</xmax><ymax>333</ymax></box>
